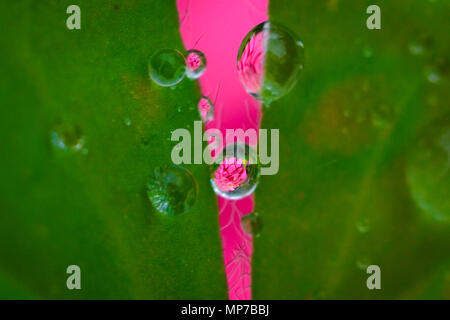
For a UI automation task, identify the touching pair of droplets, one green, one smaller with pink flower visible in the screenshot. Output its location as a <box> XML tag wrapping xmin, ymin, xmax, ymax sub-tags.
<box><xmin>148</xmin><ymin>49</ymin><xmax>206</xmax><ymax>87</ymax></box>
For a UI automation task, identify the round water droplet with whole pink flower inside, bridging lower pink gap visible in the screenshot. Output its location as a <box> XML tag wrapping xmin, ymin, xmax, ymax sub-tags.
<box><xmin>211</xmin><ymin>142</ymin><xmax>260</xmax><ymax>200</ymax></box>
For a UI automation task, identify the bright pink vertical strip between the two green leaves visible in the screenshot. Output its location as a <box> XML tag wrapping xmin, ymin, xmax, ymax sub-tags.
<box><xmin>177</xmin><ymin>0</ymin><xmax>269</xmax><ymax>299</ymax></box>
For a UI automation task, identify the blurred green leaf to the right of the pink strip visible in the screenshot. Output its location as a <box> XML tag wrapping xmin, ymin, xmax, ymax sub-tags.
<box><xmin>253</xmin><ymin>0</ymin><xmax>450</xmax><ymax>299</ymax></box>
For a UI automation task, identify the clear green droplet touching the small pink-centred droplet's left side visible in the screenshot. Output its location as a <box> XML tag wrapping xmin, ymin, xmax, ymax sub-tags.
<box><xmin>148</xmin><ymin>49</ymin><xmax>186</xmax><ymax>87</ymax></box>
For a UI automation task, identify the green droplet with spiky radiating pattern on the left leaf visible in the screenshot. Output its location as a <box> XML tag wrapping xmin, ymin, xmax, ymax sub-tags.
<box><xmin>147</xmin><ymin>165</ymin><xmax>198</xmax><ymax>216</ymax></box>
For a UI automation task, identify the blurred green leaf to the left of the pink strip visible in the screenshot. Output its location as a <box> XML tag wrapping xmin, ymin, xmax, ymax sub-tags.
<box><xmin>0</xmin><ymin>0</ymin><xmax>227</xmax><ymax>299</ymax></box>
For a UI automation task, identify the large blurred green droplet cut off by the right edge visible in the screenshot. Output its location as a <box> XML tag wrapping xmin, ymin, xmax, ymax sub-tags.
<box><xmin>406</xmin><ymin>115</ymin><xmax>450</xmax><ymax>222</ymax></box>
